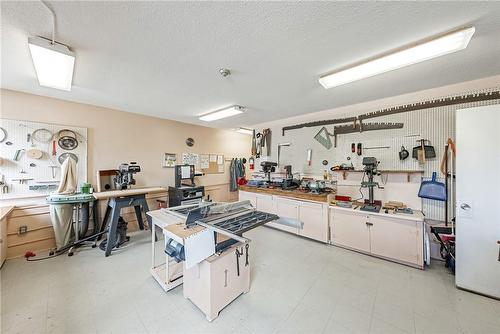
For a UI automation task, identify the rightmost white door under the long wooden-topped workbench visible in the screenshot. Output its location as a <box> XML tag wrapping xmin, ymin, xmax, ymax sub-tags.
<box><xmin>299</xmin><ymin>202</ymin><xmax>328</xmax><ymax>242</ymax></box>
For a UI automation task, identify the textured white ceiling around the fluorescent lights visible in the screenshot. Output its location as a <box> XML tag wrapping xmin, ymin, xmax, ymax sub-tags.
<box><xmin>1</xmin><ymin>1</ymin><xmax>500</xmax><ymax>127</ymax></box>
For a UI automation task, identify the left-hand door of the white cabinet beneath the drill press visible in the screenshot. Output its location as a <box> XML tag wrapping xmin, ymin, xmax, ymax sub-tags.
<box><xmin>330</xmin><ymin>209</ymin><xmax>370</xmax><ymax>252</ymax></box>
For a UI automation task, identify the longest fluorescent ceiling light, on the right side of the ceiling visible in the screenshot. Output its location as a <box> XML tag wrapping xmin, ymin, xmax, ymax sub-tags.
<box><xmin>319</xmin><ymin>27</ymin><xmax>475</xmax><ymax>88</ymax></box>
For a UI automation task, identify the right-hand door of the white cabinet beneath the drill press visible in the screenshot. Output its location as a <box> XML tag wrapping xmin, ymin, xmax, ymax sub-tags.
<box><xmin>370</xmin><ymin>216</ymin><xmax>423</xmax><ymax>264</ymax></box>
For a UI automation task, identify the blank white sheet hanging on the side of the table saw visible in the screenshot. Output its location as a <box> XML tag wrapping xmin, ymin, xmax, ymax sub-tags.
<box><xmin>184</xmin><ymin>229</ymin><xmax>215</xmax><ymax>269</ymax></box>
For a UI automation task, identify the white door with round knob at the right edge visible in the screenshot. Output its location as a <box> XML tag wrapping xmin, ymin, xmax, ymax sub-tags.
<box><xmin>455</xmin><ymin>105</ymin><xmax>500</xmax><ymax>298</ymax></box>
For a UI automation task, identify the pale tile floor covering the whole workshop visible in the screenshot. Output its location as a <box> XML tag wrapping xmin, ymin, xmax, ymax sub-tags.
<box><xmin>1</xmin><ymin>227</ymin><xmax>500</xmax><ymax>334</ymax></box>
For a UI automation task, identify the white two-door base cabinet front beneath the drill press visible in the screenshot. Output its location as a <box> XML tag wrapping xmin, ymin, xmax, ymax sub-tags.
<box><xmin>330</xmin><ymin>208</ymin><xmax>424</xmax><ymax>268</ymax></box>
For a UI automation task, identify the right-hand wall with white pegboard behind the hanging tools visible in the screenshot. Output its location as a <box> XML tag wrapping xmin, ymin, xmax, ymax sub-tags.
<box><xmin>255</xmin><ymin>76</ymin><xmax>500</xmax><ymax>220</ymax></box>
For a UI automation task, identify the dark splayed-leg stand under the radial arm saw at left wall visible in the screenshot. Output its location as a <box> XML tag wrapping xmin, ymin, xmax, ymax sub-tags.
<box><xmin>99</xmin><ymin>194</ymin><xmax>153</xmax><ymax>257</ymax></box>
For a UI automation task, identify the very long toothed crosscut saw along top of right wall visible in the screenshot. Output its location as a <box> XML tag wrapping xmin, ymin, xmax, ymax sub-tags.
<box><xmin>281</xmin><ymin>91</ymin><xmax>500</xmax><ymax>136</ymax></box>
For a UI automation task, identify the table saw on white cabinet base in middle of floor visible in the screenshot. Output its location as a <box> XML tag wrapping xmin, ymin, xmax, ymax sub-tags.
<box><xmin>147</xmin><ymin>201</ymin><xmax>278</xmax><ymax>321</ymax></box>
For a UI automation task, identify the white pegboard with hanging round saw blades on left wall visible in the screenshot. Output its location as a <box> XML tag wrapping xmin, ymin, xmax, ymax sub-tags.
<box><xmin>0</xmin><ymin>119</ymin><xmax>87</xmax><ymax>198</ymax></box>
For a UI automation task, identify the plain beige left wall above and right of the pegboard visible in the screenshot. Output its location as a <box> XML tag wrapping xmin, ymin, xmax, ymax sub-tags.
<box><xmin>0</xmin><ymin>89</ymin><xmax>251</xmax><ymax>190</ymax></box>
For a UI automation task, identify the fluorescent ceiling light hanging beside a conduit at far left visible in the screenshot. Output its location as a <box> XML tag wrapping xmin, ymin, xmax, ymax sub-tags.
<box><xmin>28</xmin><ymin>37</ymin><xmax>75</xmax><ymax>91</ymax></box>
